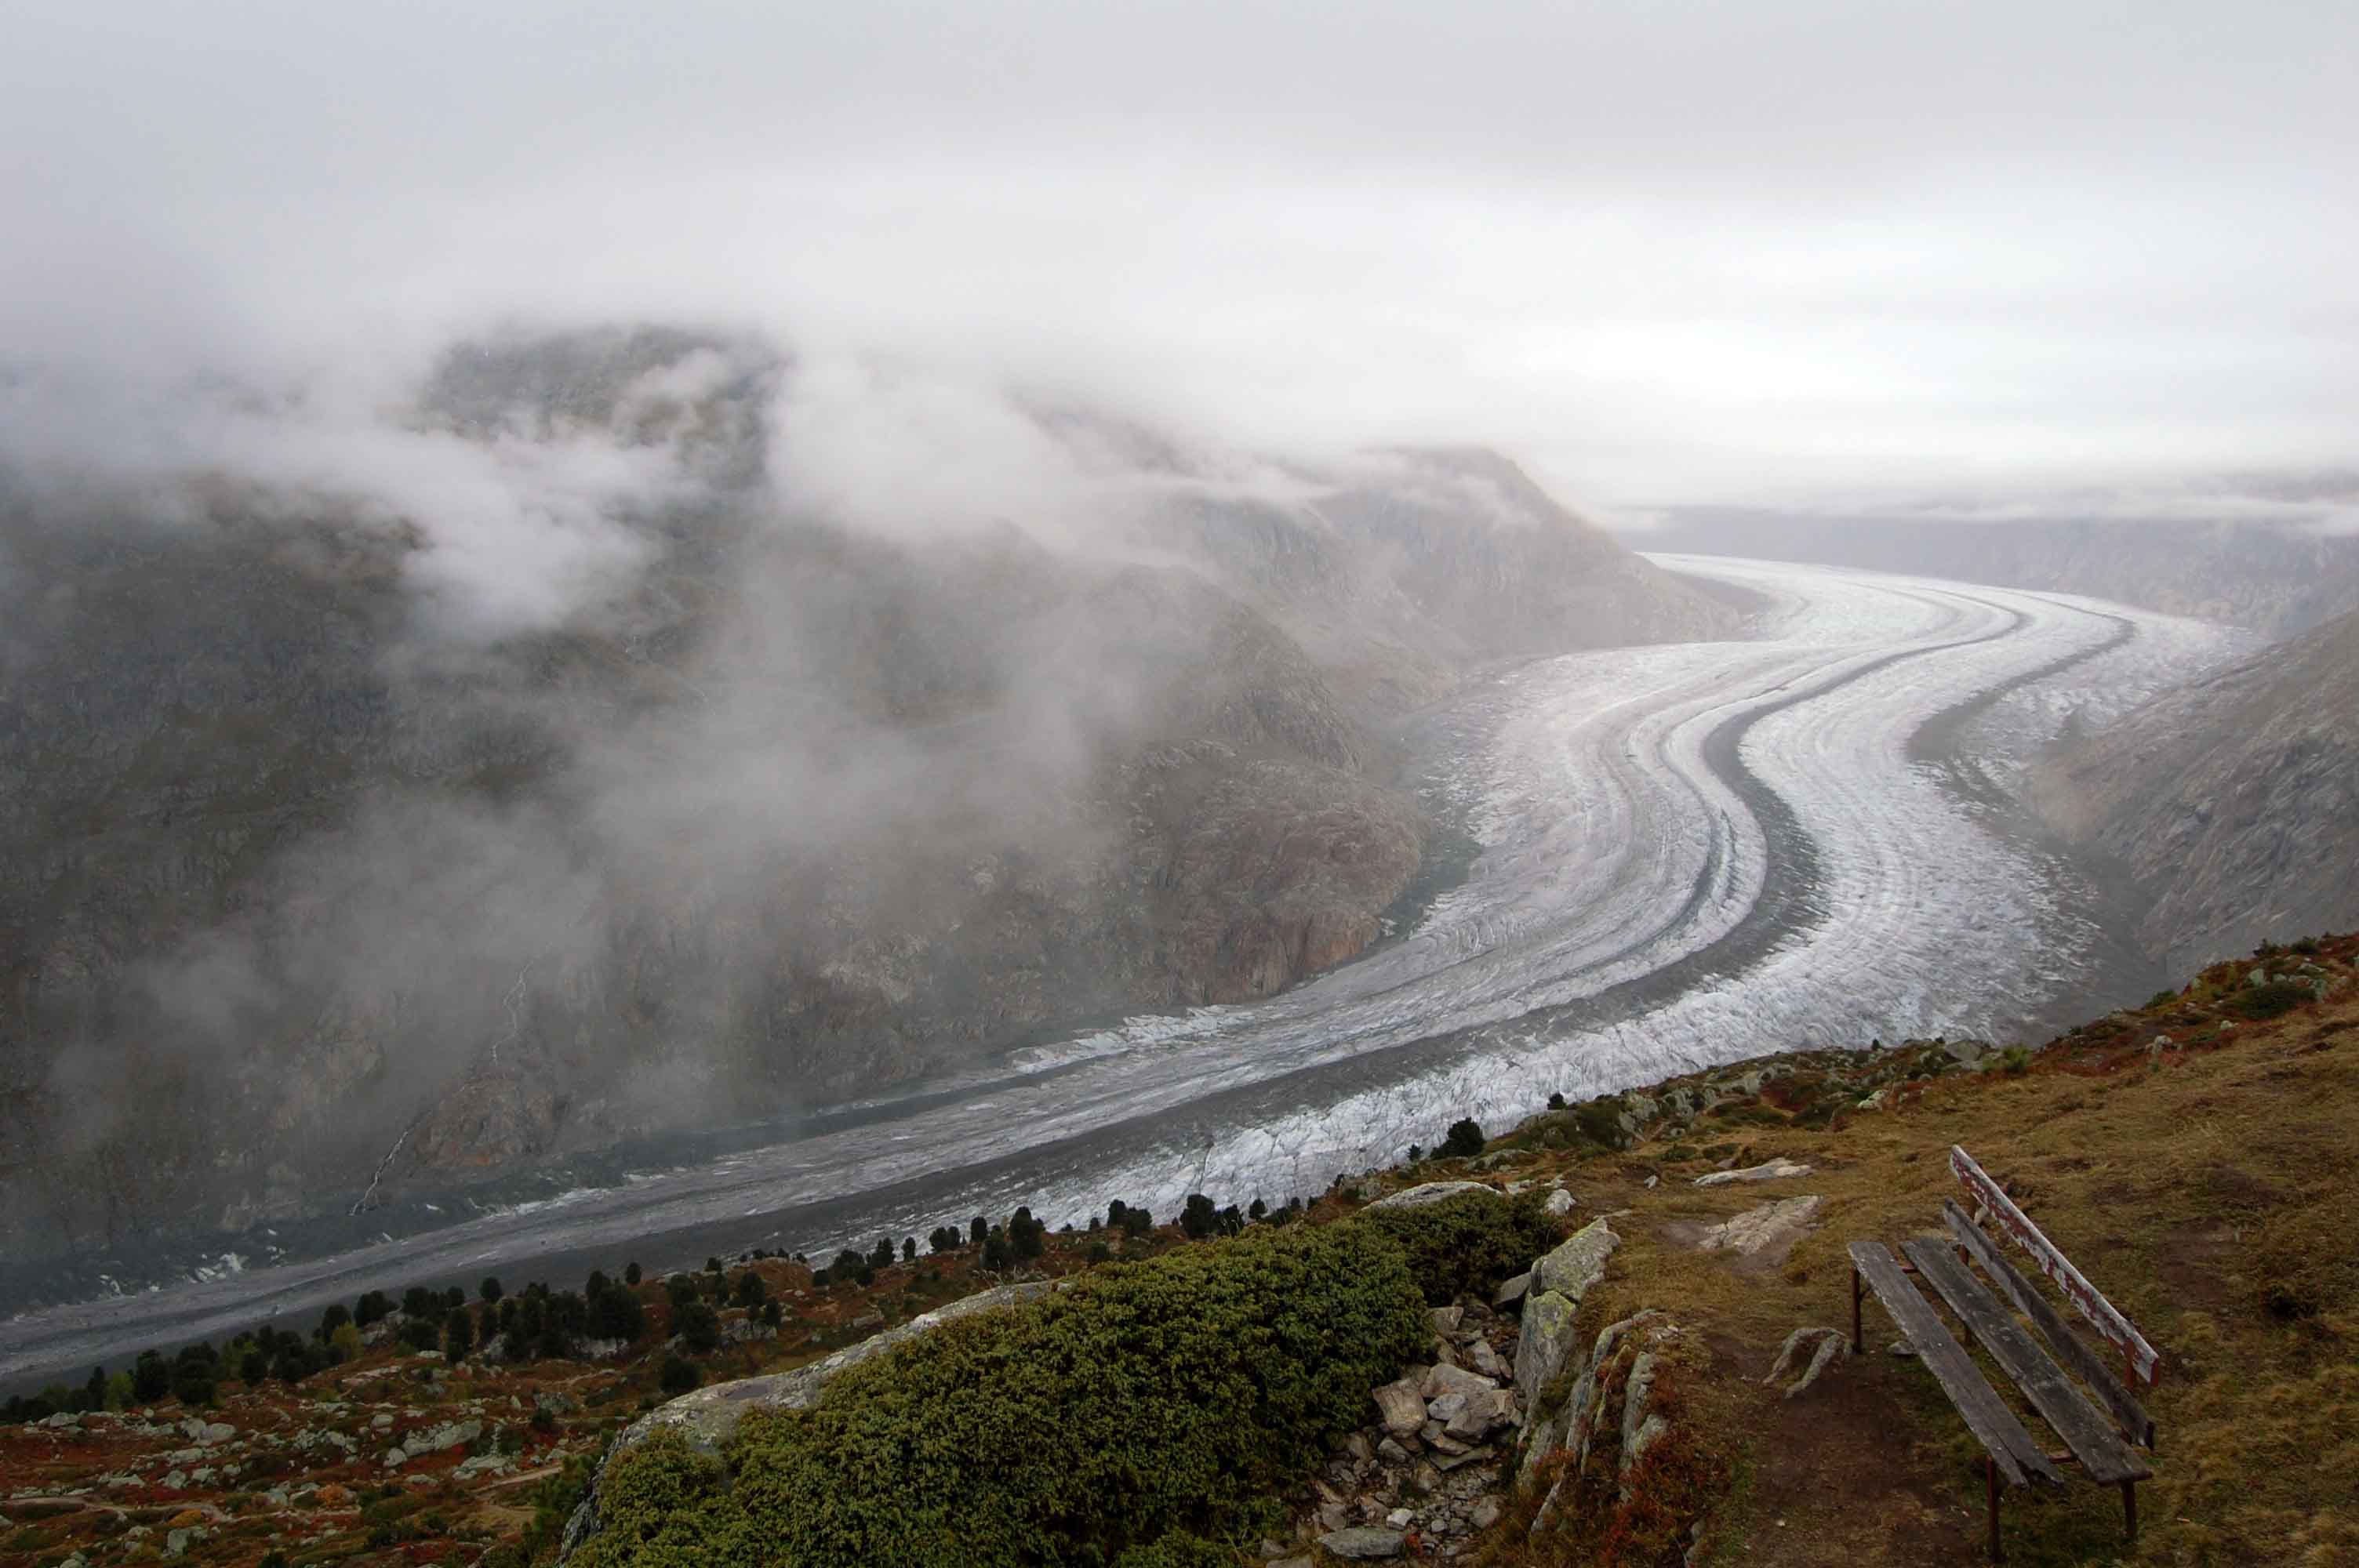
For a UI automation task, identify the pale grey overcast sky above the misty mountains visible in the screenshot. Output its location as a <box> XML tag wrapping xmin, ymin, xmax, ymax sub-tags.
<box><xmin>0</xmin><ymin>0</ymin><xmax>2359</xmax><ymax>514</ymax></box>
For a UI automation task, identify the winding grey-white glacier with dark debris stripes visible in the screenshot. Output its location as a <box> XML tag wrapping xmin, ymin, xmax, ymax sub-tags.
<box><xmin>0</xmin><ymin>557</ymin><xmax>2244</xmax><ymax>1384</ymax></box>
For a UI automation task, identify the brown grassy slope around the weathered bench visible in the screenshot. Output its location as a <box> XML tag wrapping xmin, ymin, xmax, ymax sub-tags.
<box><xmin>1452</xmin><ymin>943</ymin><xmax>2359</xmax><ymax>1568</ymax></box>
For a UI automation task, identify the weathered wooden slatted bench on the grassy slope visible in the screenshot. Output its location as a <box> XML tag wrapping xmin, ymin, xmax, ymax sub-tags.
<box><xmin>1852</xmin><ymin>1149</ymin><xmax>2161</xmax><ymax>1563</ymax></box>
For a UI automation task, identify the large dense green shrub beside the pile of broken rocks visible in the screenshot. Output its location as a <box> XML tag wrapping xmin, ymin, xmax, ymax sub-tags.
<box><xmin>578</xmin><ymin>1224</ymin><xmax>1432</xmax><ymax>1568</ymax></box>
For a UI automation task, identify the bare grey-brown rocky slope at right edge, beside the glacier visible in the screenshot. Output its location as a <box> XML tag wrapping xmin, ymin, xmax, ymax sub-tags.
<box><xmin>2029</xmin><ymin>601</ymin><xmax>2359</xmax><ymax>967</ymax></box>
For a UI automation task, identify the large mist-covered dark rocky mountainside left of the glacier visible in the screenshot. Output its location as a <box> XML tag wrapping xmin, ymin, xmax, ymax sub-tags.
<box><xmin>0</xmin><ymin>330</ymin><xmax>1732</xmax><ymax>1250</ymax></box>
